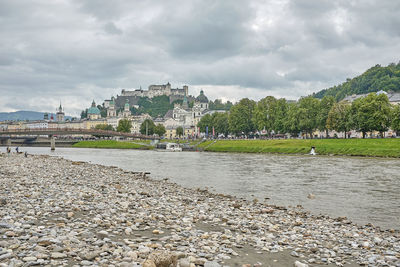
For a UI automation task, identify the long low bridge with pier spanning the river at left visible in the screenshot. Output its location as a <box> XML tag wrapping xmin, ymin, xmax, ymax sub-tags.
<box><xmin>0</xmin><ymin>128</ymin><xmax>157</xmax><ymax>150</ymax></box>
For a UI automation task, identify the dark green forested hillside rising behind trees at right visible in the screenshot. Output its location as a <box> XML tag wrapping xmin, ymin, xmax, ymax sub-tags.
<box><xmin>313</xmin><ymin>62</ymin><xmax>400</xmax><ymax>101</ymax></box>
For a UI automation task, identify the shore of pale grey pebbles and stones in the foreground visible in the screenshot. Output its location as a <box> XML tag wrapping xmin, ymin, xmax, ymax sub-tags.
<box><xmin>0</xmin><ymin>154</ymin><xmax>400</xmax><ymax>267</ymax></box>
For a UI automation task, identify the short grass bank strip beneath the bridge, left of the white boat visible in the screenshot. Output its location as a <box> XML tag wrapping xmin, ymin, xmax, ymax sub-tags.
<box><xmin>73</xmin><ymin>140</ymin><xmax>154</xmax><ymax>150</ymax></box>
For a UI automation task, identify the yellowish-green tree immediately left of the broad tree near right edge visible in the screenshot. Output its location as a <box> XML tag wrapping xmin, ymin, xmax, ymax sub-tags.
<box><xmin>326</xmin><ymin>102</ymin><xmax>351</xmax><ymax>138</ymax></box>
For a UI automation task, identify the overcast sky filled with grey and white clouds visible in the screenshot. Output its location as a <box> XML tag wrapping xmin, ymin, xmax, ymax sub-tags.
<box><xmin>0</xmin><ymin>0</ymin><xmax>400</xmax><ymax>115</ymax></box>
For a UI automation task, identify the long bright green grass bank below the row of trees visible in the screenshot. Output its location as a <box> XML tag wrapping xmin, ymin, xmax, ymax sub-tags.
<box><xmin>199</xmin><ymin>139</ymin><xmax>400</xmax><ymax>158</ymax></box>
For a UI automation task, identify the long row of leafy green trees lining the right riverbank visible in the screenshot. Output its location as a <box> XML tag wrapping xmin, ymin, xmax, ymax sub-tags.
<box><xmin>198</xmin><ymin>93</ymin><xmax>400</xmax><ymax>138</ymax></box>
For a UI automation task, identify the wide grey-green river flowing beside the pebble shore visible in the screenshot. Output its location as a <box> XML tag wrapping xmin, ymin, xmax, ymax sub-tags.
<box><xmin>18</xmin><ymin>147</ymin><xmax>400</xmax><ymax>229</ymax></box>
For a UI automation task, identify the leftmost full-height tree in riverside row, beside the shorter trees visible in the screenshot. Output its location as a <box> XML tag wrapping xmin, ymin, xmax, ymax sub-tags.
<box><xmin>229</xmin><ymin>98</ymin><xmax>256</xmax><ymax>135</ymax></box>
